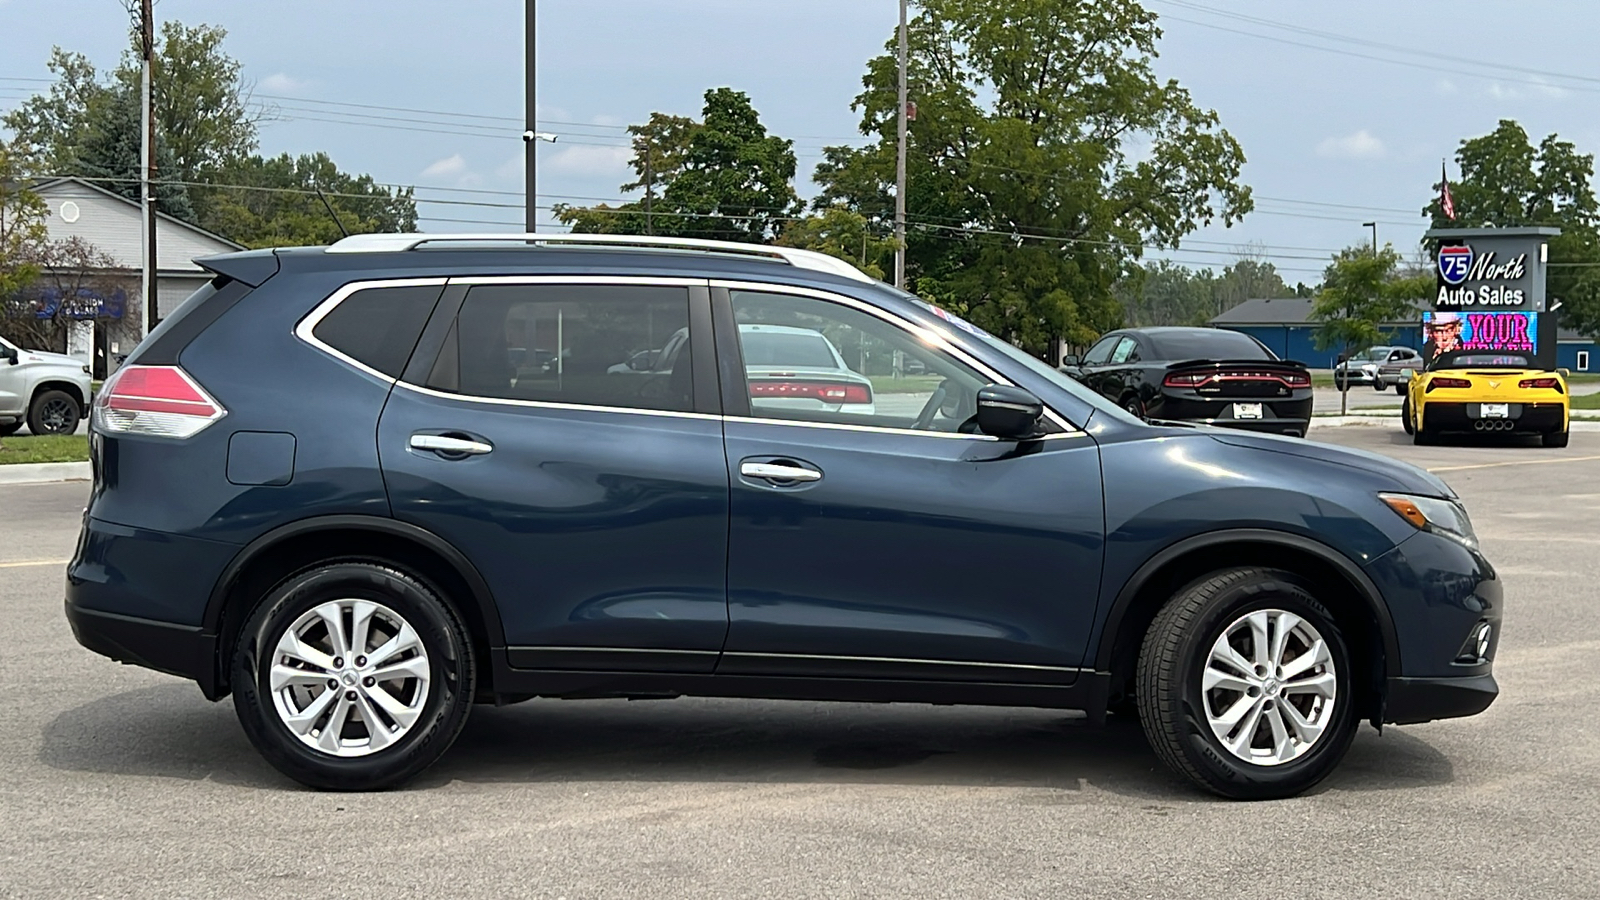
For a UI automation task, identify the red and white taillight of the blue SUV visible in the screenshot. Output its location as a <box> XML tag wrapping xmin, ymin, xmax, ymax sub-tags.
<box><xmin>94</xmin><ymin>365</ymin><xmax>227</xmax><ymax>437</ymax></box>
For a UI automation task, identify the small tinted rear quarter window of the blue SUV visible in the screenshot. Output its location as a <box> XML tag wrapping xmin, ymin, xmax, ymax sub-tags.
<box><xmin>312</xmin><ymin>285</ymin><xmax>445</xmax><ymax>378</ymax></box>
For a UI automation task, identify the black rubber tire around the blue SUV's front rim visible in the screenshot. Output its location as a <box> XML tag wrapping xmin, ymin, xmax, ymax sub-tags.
<box><xmin>1138</xmin><ymin>567</ymin><xmax>1358</xmax><ymax>799</ymax></box>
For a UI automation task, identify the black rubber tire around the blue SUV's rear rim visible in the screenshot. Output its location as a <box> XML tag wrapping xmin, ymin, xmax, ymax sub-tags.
<box><xmin>232</xmin><ymin>560</ymin><xmax>477</xmax><ymax>791</ymax></box>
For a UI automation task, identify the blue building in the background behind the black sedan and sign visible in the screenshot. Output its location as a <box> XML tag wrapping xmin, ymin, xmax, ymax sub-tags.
<box><xmin>1210</xmin><ymin>296</ymin><xmax>1600</xmax><ymax>372</ymax></box>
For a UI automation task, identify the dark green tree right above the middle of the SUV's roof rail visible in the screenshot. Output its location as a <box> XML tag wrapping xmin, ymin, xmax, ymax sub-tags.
<box><xmin>555</xmin><ymin>88</ymin><xmax>800</xmax><ymax>243</ymax></box>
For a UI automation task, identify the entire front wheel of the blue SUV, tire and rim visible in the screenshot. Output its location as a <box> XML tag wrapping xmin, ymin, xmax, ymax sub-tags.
<box><xmin>1138</xmin><ymin>567</ymin><xmax>1357</xmax><ymax>799</ymax></box>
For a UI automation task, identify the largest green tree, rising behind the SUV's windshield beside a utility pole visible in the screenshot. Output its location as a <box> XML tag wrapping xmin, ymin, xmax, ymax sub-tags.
<box><xmin>814</xmin><ymin>0</ymin><xmax>1251</xmax><ymax>352</ymax></box>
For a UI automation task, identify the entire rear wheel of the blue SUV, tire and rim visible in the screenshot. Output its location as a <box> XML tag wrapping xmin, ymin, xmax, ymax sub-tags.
<box><xmin>232</xmin><ymin>560</ymin><xmax>474</xmax><ymax>791</ymax></box>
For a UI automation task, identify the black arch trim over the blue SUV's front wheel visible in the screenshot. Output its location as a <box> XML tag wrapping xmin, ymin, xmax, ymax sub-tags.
<box><xmin>1094</xmin><ymin>528</ymin><xmax>1403</xmax><ymax>673</ymax></box>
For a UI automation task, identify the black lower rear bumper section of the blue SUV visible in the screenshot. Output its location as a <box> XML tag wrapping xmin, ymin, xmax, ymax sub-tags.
<box><xmin>67</xmin><ymin>589</ymin><xmax>219</xmax><ymax>700</ymax></box>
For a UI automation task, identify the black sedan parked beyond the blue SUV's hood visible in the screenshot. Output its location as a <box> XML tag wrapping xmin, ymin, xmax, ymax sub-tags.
<box><xmin>1061</xmin><ymin>328</ymin><xmax>1310</xmax><ymax>437</ymax></box>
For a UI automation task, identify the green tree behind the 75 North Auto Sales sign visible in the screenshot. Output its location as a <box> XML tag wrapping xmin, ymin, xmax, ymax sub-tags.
<box><xmin>1422</xmin><ymin>119</ymin><xmax>1600</xmax><ymax>336</ymax></box>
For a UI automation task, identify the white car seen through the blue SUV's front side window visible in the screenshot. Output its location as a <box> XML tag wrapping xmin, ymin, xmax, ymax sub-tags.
<box><xmin>739</xmin><ymin>325</ymin><xmax>877</xmax><ymax>416</ymax></box>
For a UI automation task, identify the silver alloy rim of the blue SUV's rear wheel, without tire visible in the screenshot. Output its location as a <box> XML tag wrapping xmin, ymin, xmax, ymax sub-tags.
<box><xmin>267</xmin><ymin>599</ymin><xmax>430</xmax><ymax>757</ymax></box>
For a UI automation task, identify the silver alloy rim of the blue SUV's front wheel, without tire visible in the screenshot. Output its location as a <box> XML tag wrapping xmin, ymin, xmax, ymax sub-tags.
<box><xmin>1200</xmin><ymin>609</ymin><xmax>1339</xmax><ymax>765</ymax></box>
